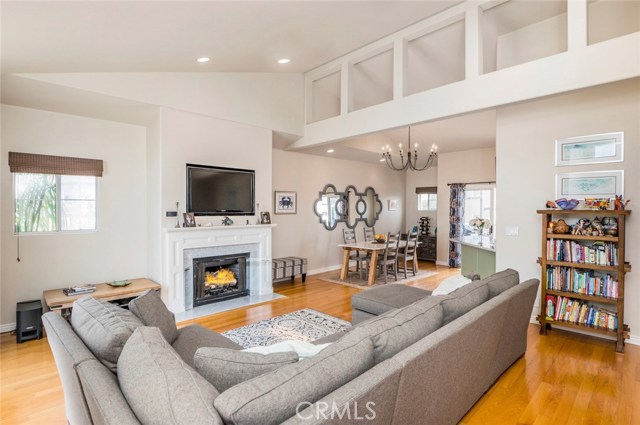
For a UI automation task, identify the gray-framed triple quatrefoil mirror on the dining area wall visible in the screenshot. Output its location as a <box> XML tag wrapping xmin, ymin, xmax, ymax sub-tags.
<box><xmin>313</xmin><ymin>184</ymin><xmax>382</xmax><ymax>230</ymax></box>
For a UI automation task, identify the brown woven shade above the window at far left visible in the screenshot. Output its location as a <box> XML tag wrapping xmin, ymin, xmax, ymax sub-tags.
<box><xmin>9</xmin><ymin>152</ymin><xmax>102</xmax><ymax>177</ymax></box>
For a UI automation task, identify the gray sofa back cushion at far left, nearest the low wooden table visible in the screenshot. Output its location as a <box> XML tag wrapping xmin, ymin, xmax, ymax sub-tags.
<box><xmin>71</xmin><ymin>297</ymin><xmax>143</xmax><ymax>372</ymax></box>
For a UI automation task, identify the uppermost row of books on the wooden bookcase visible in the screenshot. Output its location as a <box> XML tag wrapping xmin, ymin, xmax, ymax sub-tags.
<box><xmin>547</xmin><ymin>239</ymin><xmax>618</xmax><ymax>266</ymax></box>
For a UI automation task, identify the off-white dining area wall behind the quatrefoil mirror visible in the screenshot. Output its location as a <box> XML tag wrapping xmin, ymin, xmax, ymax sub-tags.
<box><xmin>267</xmin><ymin>149</ymin><xmax>405</xmax><ymax>272</ymax></box>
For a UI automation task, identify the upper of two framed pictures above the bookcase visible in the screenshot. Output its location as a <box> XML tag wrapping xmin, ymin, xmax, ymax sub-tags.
<box><xmin>556</xmin><ymin>132</ymin><xmax>624</xmax><ymax>166</ymax></box>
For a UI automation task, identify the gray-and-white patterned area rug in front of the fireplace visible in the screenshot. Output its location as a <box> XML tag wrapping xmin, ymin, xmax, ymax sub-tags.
<box><xmin>222</xmin><ymin>308</ymin><xmax>351</xmax><ymax>348</ymax></box>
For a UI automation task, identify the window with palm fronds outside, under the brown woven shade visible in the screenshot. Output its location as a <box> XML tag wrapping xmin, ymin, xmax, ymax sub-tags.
<box><xmin>14</xmin><ymin>173</ymin><xmax>97</xmax><ymax>233</ymax></box>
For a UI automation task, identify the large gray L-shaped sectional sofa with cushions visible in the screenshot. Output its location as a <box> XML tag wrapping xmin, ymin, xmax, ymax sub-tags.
<box><xmin>43</xmin><ymin>270</ymin><xmax>538</xmax><ymax>425</ymax></box>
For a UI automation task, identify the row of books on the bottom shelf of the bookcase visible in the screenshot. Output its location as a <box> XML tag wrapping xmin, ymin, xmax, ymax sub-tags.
<box><xmin>545</xmin><ymin>295</ymin><xmax>618</xmax><ymax>331</ymax></box>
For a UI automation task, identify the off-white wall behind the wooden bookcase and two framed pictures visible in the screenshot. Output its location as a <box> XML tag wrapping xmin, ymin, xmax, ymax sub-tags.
<box><xmin>496</xmin><ymin>78</ymin><xmax>640</xmax><ymax>343</ymax></box>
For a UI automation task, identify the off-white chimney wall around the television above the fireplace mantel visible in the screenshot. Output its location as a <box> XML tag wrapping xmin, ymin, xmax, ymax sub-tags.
<box><xmin>161</xmin><ymin>109</ymin><xmax>272</xmax><ymax>227</ymax></box>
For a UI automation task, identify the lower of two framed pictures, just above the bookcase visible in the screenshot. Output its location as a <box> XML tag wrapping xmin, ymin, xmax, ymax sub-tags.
<box><xmin>556</xmin><ymin>170</ymin><xmax>624</xmax><ymax>199</ymax></box>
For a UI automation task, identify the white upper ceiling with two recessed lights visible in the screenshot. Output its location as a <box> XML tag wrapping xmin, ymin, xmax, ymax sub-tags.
<box><xmin>1</xmin><ymin>0</ymin><xmax>459</xmax><ymax>73</ymax></box>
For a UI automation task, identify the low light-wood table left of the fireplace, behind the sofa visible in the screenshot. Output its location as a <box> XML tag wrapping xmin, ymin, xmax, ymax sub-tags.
<box><xmin>44</xmin><ymin>279</ymin><xmax>160</xmax><ymax>314</ymax></box>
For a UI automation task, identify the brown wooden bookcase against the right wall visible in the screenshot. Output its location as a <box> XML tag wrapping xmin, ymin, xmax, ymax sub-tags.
<box><xmin>537</xmin><ymin>210</ymin><xmax>631</xmax><ymax>353</ymax></box>
